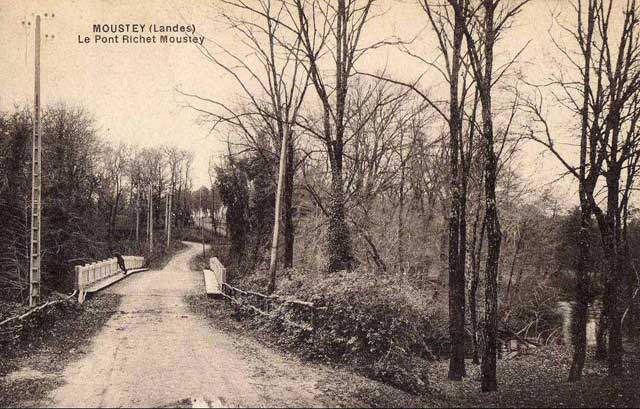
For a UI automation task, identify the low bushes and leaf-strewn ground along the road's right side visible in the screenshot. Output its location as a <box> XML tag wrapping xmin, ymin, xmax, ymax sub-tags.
<box><xmin>196</xmin><ymin>231</ymin><xmax>640</xmax><ymax>407</ymax></box>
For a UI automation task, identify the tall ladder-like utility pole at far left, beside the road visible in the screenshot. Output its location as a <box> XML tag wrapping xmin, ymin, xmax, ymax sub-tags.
<box><xmin>29</xmin><ymin>15</ymin><xmax>42</xmax><ymax>307</ymax></box>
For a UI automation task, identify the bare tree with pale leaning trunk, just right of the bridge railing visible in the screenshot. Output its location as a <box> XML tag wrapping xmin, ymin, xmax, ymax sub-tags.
<box><xmin>180</xmin><ymin>0</ymin><xmax>308</xmax><ymax>291</ymax></box>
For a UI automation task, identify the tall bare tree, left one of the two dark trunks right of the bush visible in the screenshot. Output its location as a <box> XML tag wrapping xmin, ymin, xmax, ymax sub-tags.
<box><xmin>360</xmin><ymin>0</ymin><xmax>478</xmax><ymax>380</ymax></box>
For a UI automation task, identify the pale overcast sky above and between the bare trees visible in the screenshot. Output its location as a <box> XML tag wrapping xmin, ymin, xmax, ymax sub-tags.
<box><xmin>0</xmin><ymin>0</ymin><xmax>592</xmax><ymax>202</ymax></box>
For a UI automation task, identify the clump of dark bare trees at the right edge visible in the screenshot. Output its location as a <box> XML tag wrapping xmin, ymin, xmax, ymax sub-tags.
<box><xmin>529</xmin><ymin>0</ymin><xmax>640</xmax><ymax>380</ymax></box>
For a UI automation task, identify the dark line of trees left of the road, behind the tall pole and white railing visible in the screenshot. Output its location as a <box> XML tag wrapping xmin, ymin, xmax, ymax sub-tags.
<box><xmin>0</xmin><ymin>103</ymin><xmax>206</xmax><ymax>301</ymax></box>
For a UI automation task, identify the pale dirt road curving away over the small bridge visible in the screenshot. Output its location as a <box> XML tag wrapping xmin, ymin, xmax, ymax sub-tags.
<box><xmin>42</xmin><ymin>244</ymin><xmax>335</xmax><ymax>407</ymax></box>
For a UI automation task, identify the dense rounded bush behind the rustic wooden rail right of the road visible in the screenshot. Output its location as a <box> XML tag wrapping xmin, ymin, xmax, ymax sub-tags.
<box><xmin>244</xmin><ymin>269</ymin><xmax>447</xmax><ymax>393</ymax></box>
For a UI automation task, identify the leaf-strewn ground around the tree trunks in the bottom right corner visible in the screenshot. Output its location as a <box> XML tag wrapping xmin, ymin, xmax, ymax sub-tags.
<box><xmin>430</xmin><ymin>345</ymin><xmax>640</xmax><ymax>408</ymax></box>
